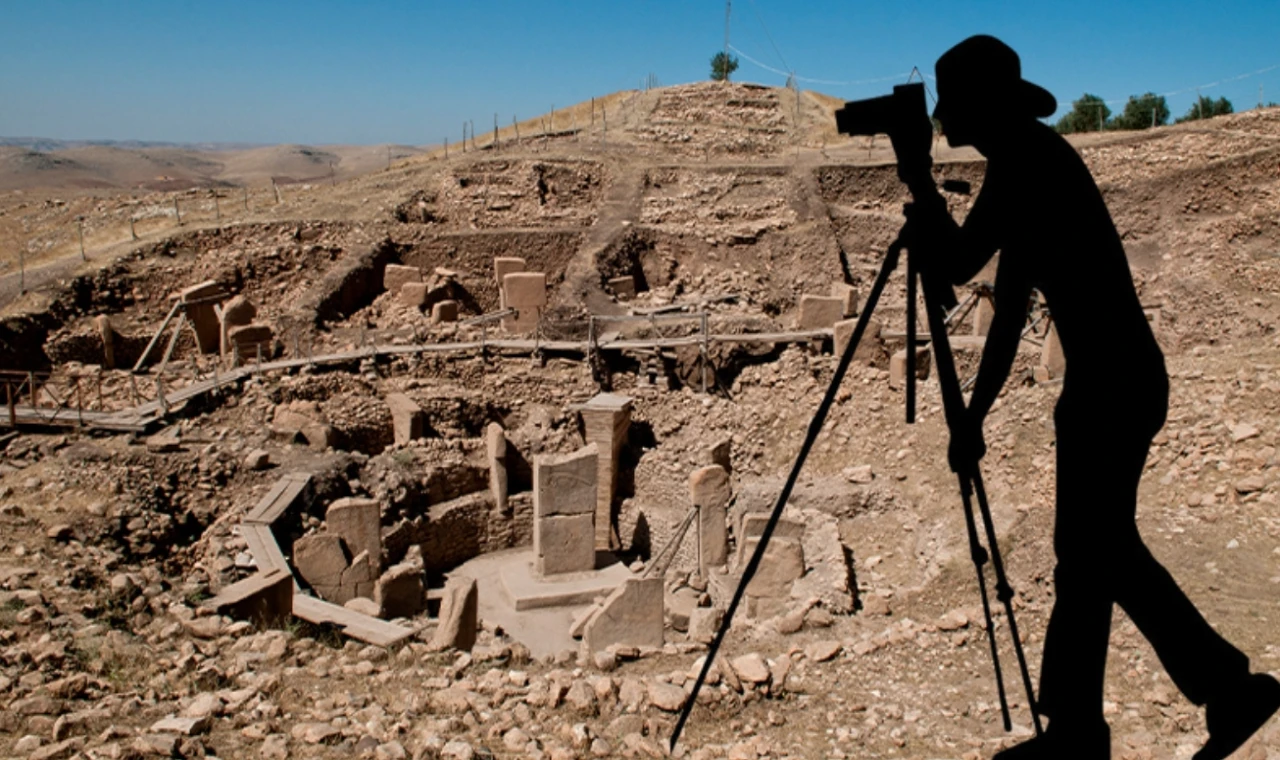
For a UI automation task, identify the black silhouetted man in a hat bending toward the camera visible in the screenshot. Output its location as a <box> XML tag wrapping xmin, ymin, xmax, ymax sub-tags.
<box><xmin>909</xmin><ymin>36</ymin><xmax>1280</xmax><ymax>760</ymax></box>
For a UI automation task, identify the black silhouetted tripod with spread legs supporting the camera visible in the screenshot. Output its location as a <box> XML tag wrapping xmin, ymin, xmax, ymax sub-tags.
<box><xmin>671</xmin><ymin>163</ymin><xmax>1043</xmax><ymax>750</ymax></box>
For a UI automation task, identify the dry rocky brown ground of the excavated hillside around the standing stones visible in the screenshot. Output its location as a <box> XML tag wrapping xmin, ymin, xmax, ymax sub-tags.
<box><xmin>0</xmin><ymin>84</ymin><xmax>1280</xmax><ymax>760</ymax></box>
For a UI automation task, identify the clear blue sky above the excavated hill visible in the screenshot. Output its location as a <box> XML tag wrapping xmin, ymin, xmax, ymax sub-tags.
<box><xmin>0</xmin><ymin>0</ymin><xmax>1280</xmax><ymax>145</ymax></box>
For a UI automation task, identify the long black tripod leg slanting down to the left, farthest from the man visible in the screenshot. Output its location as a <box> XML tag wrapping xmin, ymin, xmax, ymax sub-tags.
<box><xmin>671</xmin><ymin>241</ymin><xmax>902</xmax><ymax>751</ymax></box>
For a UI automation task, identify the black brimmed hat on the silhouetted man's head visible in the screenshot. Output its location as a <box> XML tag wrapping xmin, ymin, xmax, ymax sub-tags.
<box><xmin>934</xmin><ymin>35</ymin><xmax>1057</xmax><ymax>119</ymax></box>
